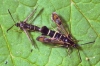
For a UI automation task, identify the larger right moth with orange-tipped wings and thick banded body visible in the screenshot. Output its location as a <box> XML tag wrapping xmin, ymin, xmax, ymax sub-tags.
<box><xmin>37</xmin><ymin>12</ymin><xmax>81</xmax><ymax>60</ymax></box>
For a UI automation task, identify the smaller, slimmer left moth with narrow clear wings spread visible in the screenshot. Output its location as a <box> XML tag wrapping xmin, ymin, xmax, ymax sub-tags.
<box><xmin>7</xmin><ymin>9</ymin><xmax>40</xmax><ymax>46</ymax></box>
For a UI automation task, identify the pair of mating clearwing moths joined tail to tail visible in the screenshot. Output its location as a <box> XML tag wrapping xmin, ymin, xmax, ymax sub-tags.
<box><xmin>7</xmin><ymin>9</ymin><xmax>93</xmax><ymax>60</ymax></box>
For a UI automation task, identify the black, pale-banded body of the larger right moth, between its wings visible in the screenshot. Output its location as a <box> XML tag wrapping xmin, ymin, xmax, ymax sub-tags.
<box><xmin>38</xmin><ymin>26</ymin><xmax>73</xmax><ymax>47</ymax></box>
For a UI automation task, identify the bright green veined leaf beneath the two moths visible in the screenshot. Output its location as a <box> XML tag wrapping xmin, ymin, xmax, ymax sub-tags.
<box><xmin>0</xmin><ymin>0</ymin><xmax>100</xmax><ymax>66</ymax></box>
